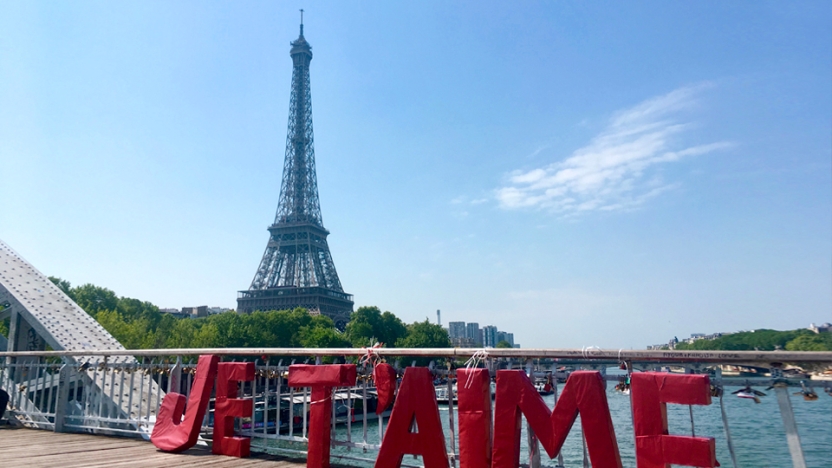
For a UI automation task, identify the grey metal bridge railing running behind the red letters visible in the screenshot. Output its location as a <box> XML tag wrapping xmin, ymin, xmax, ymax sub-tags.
<box><xmin>0</xmin><ymin>348</ymin><xmax>832</xmax><ymax>468</ymax></box>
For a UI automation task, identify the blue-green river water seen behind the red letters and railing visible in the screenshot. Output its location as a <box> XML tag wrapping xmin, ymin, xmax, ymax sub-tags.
<box><xmin>316</xmin><ymin>384</ymin><xmax>832</xmax><ymax>468</ymax></box>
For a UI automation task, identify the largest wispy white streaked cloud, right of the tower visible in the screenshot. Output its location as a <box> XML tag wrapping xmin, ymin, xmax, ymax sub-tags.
<box><xmin>496</xmin><ymin>84</ymin><xmax>731</xmax><ymax>215</ymax></box>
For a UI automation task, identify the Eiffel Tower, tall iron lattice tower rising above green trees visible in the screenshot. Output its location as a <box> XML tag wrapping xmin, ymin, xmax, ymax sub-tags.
<box><xmin>237</xmin><ymin>17</ymin><xmax>353</xmax><ymax>330</ymax></box>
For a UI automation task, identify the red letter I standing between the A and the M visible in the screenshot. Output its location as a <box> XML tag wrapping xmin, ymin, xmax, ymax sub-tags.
<box><xmin>456</xmin><ymin>369</ymin><xmax>491</xmax><ymax>468</ymax></box>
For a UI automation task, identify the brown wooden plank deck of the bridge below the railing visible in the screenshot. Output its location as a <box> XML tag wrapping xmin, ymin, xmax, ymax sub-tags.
<box><xmin>0</xmin><ymin>426</ymin><xmax>306</xmax><ymax>468</ymax></box>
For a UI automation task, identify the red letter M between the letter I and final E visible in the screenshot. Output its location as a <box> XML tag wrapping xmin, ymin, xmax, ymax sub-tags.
<box><xmin>490</xmin><ymin>370</ymin><xmax>621</xmax><ymax>468</ymax></box>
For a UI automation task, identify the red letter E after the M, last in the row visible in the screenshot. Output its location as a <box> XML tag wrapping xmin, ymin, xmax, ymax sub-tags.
<box><xmin>630</xmin><ymin>372</ymin><xmax>719</xmax><ymax>468</ymax></box>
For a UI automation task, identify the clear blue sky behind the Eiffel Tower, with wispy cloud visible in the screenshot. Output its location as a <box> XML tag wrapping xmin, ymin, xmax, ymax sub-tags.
<box><xmin>0</xmin><ymin>0</ymin><xmax>832</xmax><ymax>348</ymax></box>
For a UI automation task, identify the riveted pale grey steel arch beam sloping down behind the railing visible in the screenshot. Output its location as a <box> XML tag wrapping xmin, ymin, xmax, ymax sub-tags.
<box><xmin>0</xmin><ymin>240</ymin><xmax>164</xmax><ymax>427</ymax></box>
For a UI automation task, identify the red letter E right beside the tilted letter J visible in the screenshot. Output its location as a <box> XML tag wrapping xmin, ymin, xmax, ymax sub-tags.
<box><xmin>212</xmin><ymin>362</ymin><xmax>254</xmax><ymax>458</ymax></box>
